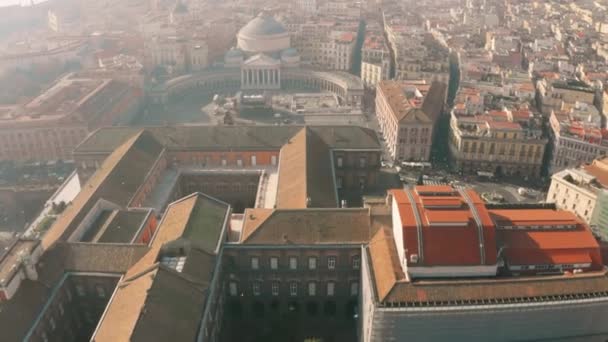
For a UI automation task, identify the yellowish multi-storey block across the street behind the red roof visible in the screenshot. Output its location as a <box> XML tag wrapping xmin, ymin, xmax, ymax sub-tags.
<box><xmin>449</xmin><ymin>88</ymin><xmax>548</xmax><ymax>177</ymax></box>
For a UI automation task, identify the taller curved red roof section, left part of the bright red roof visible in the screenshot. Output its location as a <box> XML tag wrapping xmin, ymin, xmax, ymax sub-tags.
<box><xmin>390</xmin><ymin>186</ymin><xmax>496</xmax><ymax>266</ymax></box>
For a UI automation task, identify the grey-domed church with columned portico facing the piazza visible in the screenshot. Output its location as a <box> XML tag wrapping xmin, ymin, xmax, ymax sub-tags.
<box><xmin>224</xmin><ymin>13</ymin><xmax>300</xmax><ymax>90</ymax></box>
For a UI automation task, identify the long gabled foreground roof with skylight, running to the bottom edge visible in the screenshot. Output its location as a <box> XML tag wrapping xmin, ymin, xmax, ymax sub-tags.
<box><xmin>95</xmin><ymin>193</ymin><xmax>228</xmax><ymax>341</ymax></box>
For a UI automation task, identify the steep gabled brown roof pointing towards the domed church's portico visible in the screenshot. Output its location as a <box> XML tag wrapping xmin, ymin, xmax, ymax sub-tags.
<box><xmin>276</xmin><ymin>128</ymin><xmax>338</xmax><ymax>209</ymax></box>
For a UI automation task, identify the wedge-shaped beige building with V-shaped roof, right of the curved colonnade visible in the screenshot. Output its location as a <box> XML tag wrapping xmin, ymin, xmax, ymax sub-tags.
<box><xmin>376</xmin><ymin>81</ymin><xmax>447</xmax><ymax>161</ymax></box>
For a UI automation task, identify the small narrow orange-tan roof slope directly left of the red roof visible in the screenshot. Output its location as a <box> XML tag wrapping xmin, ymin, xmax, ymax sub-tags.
<box><xmin>367</xmin><ymin>229</ymin><xmax>405</xmax><ymax>302</ymax></box>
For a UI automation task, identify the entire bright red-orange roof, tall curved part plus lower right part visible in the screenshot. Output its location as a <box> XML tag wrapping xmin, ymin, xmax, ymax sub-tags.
<box><xmin>390</xmin><ymin>186</ymin><xmax>602</xmax><ymax>269</ymax></box>
